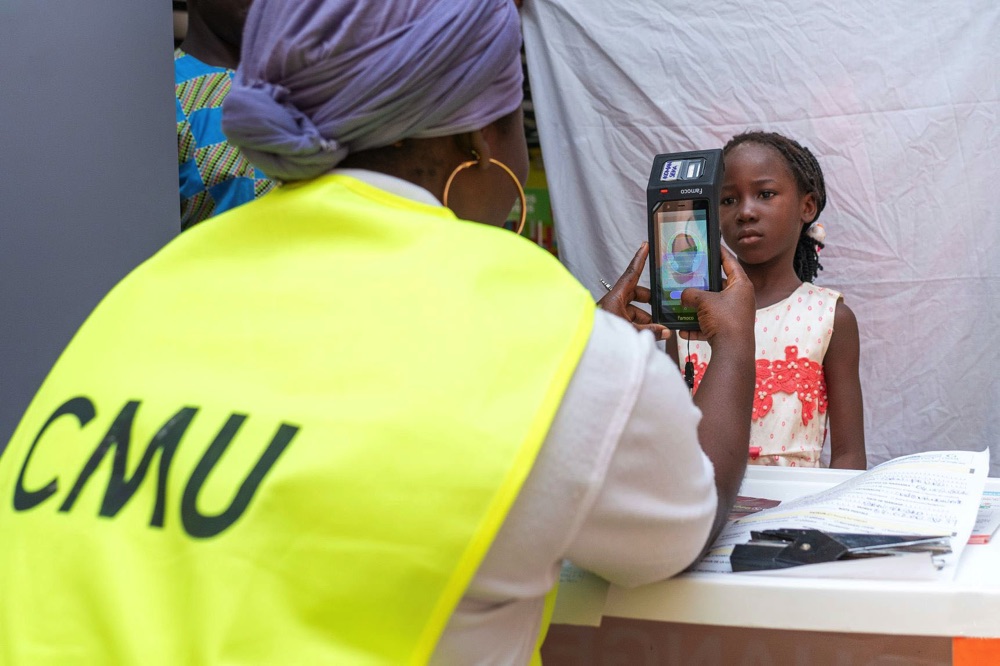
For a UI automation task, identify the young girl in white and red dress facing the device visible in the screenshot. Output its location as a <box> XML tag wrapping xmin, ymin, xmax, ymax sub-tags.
<box><xmin>669</xmin><ymin>132</ymin><xmax>866</xmax><ymax>469</ymax></box>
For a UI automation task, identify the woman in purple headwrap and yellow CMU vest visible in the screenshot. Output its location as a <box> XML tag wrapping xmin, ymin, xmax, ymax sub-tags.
<box><xmin>0</xmin><ymin>0</ymin><xmax>754</xmax><ymax>664</ymax></box>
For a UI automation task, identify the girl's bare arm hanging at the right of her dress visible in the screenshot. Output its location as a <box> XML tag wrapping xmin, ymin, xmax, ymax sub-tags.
<box><xmin>823</xmin><ymin>300</ymin><xmax>868</xmax><ymax>469</ymax></box>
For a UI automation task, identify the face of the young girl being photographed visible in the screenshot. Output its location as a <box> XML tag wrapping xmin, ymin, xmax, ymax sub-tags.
<box><xmin>719</xmin><ymin>142</ymin><xmax>816</xmax><ymax>269</ymax></box>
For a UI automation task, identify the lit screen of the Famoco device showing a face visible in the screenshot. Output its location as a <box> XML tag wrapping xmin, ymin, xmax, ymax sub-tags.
<box><xmin>653</xmin><ymin>199</ymin><xmax>709</xmax><ymax>321</ymax></box>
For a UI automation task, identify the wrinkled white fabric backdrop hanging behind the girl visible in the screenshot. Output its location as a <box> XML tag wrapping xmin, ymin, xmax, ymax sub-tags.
<box><xmin>522</xmin><ymin>0</ymin><xmax>1000</xmax><ymax>475</ymax></box>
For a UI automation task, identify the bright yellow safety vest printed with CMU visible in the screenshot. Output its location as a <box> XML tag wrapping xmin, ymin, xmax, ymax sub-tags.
<box><xmin>0</xmin><ymin>175</ymin><xmax>594</xmax><ymax>666</ymax></box>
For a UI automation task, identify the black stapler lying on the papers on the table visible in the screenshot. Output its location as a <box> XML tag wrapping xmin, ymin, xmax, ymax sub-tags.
<box><xmin>729</xmin><ymin>528</ymin><xmax>951</xmax><ymax>571</ymax></box>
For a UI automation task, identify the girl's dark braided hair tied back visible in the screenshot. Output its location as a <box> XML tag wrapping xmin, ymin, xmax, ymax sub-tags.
<box><xmin>722</xmin><ymin>131</ymin><xmax>826</xmax><ymax>282</ymax></box>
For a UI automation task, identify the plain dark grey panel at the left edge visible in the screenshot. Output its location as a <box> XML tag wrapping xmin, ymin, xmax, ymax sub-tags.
<box><xmin>0</xmin><ymin>0</ymin><xmax>178</xmax><ymax>450</ymax></box>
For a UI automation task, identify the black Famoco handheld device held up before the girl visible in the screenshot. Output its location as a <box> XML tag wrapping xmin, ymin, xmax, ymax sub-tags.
<box><xmin>647</xmin><ymin>150</ymin><xmax>722</xmax><ymax>330</ymax></box>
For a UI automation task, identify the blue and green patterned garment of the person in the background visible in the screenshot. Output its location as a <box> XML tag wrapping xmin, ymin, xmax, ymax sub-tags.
<box><xmin>174</xmin><ymin>49</ymin><xmax>274</xmax><ymax>229</ymax></box>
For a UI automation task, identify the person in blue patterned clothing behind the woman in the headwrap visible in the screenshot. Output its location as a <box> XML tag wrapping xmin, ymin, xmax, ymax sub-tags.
<box><xmin>174</xmin><ymin>0</ymin><xmax>274</xmax><ymax>230</ymax></box>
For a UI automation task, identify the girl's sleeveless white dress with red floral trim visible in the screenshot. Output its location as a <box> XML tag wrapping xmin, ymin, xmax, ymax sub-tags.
<box><xmin>677</xmin><ymin>282</ymin><xmax>841</xmax><ymax>467</ymax></box>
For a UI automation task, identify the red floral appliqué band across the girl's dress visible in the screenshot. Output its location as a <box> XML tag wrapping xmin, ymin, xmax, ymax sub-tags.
<box><xmin>753</xmin><ymin>345</ymin><xmax>827</xmax><ymax>425</ymax></box>
